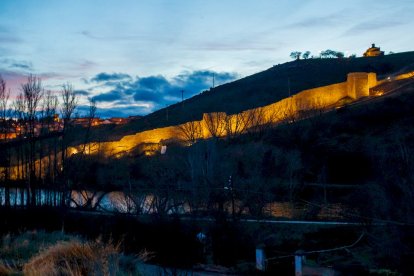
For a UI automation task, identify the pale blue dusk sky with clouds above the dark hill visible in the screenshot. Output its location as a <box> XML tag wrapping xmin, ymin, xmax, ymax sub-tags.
<box><xmin>0</xmin><ymin>0</ymin><xmax>414</xmax><ymax>117</ymax></box>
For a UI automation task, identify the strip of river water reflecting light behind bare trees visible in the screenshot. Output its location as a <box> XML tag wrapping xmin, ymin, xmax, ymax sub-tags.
<box><xmin>0</xmin><ymin>187</ymin><xmax>346</xmax><ymax>219</ymax></box>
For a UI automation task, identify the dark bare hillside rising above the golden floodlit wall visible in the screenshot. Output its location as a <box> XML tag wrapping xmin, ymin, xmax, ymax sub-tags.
<box><xmin>95</xmin><ymin>52</ymin><xmax>414</xmax><ymax>140</ymax></box>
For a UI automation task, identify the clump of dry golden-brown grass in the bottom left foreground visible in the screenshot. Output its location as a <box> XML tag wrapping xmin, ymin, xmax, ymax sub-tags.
<box><xmin>23</xmin><ymin>241</ymin><xmax>120</xmax><ymax>276</ymax></box>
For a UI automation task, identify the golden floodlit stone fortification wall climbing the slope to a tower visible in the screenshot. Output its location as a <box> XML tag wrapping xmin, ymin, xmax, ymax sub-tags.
<box><xmin>94</xmin><ymin>72</ymin><xmax>377</xmax><ymax>155</ymax></box>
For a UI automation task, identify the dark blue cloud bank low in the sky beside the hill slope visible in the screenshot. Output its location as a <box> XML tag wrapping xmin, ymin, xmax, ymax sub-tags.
<box><xmin>93</xmin><ymin>70</ymin><xmax>238</xmax><ymax>115</ymax></box>
